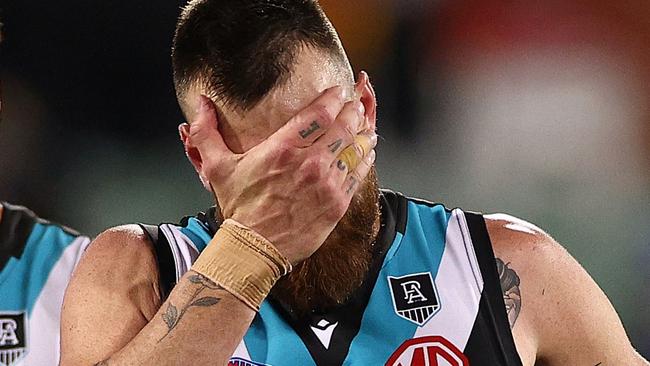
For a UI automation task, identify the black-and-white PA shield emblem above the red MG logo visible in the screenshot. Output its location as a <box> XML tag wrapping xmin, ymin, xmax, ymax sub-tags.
<box><xmin>388</xmin><ymin>272</ymin><xmax>440</xmax><ymax>326</ymax></box>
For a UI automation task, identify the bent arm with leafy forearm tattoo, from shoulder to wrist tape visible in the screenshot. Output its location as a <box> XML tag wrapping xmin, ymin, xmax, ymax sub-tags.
<box><xmin>61</xmin><ymin>226</ymin><xmax>255</xmax><ymax>366</ymax></box>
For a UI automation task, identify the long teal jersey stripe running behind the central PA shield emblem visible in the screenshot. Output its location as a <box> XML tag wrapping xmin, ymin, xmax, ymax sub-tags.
<box><xmin>343</xmin><ymin>201</ymin><xmax>450</xmax><ymax>365</ymax></box>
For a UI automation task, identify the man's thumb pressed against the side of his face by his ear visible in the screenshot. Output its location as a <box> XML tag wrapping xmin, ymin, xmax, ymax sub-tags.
<box><xmin>188</xmin><ymin>95</ymin><xmax>234</xmax><ymax>159</ymax></box>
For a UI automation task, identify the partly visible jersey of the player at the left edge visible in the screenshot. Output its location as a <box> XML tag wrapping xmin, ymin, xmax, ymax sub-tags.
<box><xmin>0</xmin><ymin>202</ymin><xmax>90</xmax><ymax>366</ymax></box>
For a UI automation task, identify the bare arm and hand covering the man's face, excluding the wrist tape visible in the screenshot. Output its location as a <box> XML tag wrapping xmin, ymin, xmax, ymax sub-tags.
<box><xmin>61</xmin><ymin>78</ymin><xmax>374</xmax><ymax>366</ymax></box>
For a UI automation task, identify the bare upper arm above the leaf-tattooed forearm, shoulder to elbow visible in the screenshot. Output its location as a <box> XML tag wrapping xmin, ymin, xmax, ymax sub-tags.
<box><xmin>61</xmin><ymin>226</ymin><xmax>160</xmax><ymax>364</ymax></box>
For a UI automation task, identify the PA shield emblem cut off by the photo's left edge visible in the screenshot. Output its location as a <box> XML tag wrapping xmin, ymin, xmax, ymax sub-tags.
<box><xmin>0</xmin><ymin>312</ymin><xmax>27</xmax><ymax>366</ymax></box>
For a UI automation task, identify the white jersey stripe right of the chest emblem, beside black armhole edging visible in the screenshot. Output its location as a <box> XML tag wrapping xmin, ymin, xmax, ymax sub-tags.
<box><xmin>413</xmin><ymin>209</ymin><xmax>483</xmax><ymax>350</ymax></box>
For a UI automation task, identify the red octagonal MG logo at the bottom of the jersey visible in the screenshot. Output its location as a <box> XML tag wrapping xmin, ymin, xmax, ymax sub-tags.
<box><xmin>386</xmin><ymin>336</ymin><xmax>469</xmax><ymax>366</ymax></box>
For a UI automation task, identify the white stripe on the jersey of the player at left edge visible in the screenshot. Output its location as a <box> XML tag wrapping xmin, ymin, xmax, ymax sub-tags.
<box><xmin>18</xmin><ymin>236</ymin><xmax>90</xmax><ymax>366</ymax></box>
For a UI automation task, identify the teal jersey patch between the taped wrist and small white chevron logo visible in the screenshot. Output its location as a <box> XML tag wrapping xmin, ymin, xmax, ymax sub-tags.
<box><xmin>244</xmin><ymin>301</ymin><xmax>315</xmax><ymax>366</ymax></box>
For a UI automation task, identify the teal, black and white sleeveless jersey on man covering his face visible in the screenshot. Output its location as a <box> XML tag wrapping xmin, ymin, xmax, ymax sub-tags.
<box><xmin>143</xmin><ymin>190</ymin><xmax>521</xmax><ymax>366</ymax></box>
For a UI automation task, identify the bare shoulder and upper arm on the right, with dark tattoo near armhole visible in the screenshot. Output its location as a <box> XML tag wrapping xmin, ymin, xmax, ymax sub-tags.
<box><xmin>486</xmin><ymin>215</ymin><xmax>648</xmax><ymax>366</ymax></box>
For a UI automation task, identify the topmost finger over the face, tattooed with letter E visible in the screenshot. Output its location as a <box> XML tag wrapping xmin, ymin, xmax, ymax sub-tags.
<box><xmin>270</xmin><ymin>86</ymin><xmax>346</xmax><ymax>147</ymax></box>
